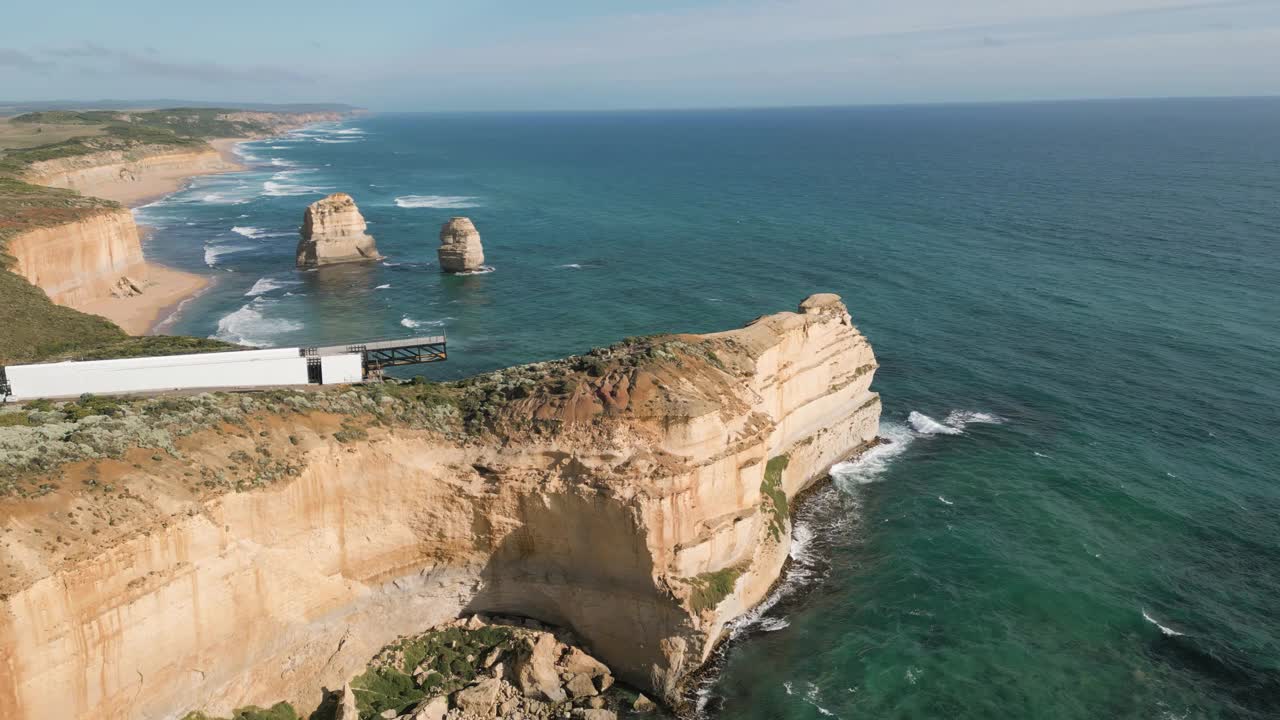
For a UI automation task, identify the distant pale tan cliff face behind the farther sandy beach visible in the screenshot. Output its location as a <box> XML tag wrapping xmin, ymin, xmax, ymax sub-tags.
<box><xmin>23</xmin><ymin>145</ymin><xmax>238</xmax><ymax>202</ymax></box>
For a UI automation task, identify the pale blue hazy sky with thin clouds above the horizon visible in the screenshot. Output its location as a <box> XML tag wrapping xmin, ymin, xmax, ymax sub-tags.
<box><xmin>0</xmin><ymin>0</ymin><xmax>1280</xmax><ymax>110</ymax></box>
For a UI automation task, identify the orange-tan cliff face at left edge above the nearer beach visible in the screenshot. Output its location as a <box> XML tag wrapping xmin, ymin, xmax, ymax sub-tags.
<box><xmin>8</xmin><ymin>209</ymin><xmax>147</xmax><ymax>307</ymax></box>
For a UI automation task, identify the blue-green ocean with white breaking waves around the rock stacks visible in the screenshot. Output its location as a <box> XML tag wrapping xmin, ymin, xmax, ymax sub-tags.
<box><xmin>137</xmin><ymin>100</ymin><xmax>1280</xmax><ymax>720</ymax></box>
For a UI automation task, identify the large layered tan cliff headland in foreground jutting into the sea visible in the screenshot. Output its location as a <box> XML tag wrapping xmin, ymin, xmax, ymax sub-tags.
<box><xmin>0</xmin><ymin>296</ymin><xmax>879</xmax><ymax>720</ymax></box>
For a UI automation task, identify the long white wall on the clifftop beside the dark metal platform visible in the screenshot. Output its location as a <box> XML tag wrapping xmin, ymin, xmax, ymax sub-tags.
<box><xmin>5</xmin><ymin>347</ymin><xmax>364</xmax><ymax>400</ymax></box>
